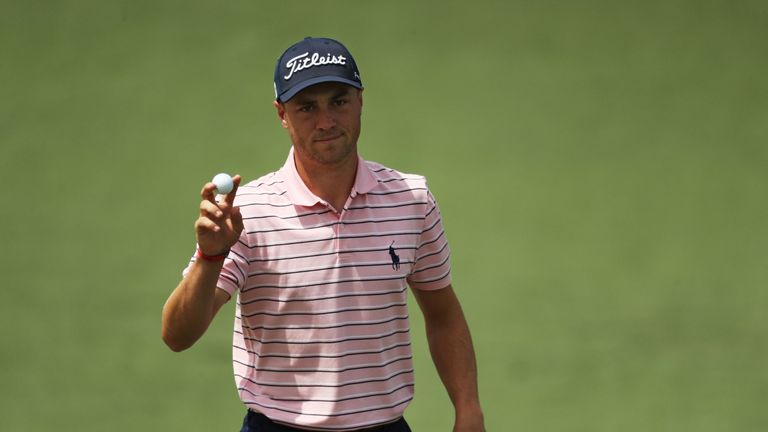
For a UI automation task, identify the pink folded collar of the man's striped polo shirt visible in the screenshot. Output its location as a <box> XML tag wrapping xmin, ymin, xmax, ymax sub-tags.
<box><xmin>280</xmin><ymin>146</ymin><xmax>379</xmax><ymax>207</ymax></box>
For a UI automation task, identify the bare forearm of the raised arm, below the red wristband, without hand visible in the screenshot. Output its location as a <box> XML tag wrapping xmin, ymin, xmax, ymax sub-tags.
<box><xmin>162</xmin><ymin>260</ymin><xmax>222</xmax><ymax>351</ymax></box>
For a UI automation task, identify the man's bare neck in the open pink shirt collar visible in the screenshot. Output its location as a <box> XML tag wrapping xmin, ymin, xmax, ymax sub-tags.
<box><xmin>293</xmin><ymin>153</ymin><xmax>358</xmax><ymax>213</ymax></box>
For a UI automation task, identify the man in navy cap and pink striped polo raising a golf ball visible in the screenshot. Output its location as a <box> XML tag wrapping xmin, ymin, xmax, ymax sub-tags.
<box><xmin>162</xmin><ymin>38</ymin><xmax>484</xmax><ymax>432</ymax></box>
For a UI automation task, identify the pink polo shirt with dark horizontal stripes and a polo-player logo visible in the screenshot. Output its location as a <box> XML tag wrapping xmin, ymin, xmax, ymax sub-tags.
<box><xmin>185</xmin><ymin>149</ymin><xmax>451</xmax><ymax>431</ymax></box>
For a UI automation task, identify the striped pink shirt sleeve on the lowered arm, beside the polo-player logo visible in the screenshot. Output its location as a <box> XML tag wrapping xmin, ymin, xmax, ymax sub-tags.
<box><xmin>407</xmin><ymin>191</ymin><xmax>451</xmax><ymax>290</ymax></box>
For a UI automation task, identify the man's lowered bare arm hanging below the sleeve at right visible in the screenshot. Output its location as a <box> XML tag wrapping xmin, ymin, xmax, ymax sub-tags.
<box><xmin>412</xmin><ymin>285</ymin><xmax>485</xmax><ymax>432</ymax></box>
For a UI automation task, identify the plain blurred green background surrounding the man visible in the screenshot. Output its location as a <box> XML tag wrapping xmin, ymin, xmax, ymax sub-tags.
<box><xmin>0</xmin><ymin>0</ymin><xmax>768</xmax><ymax>432</ymax></box>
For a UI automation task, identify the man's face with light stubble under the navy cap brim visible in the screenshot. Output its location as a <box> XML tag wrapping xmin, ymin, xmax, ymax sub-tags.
<box><xmin>275</xmin><ymin>82</ymin><xmax>363</xmax><ymax>167</ymax></box>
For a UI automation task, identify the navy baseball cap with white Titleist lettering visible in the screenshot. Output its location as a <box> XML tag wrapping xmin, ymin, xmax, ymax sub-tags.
<box><xmin>275</xmin><ymin>37</ymin><xmax>363</xmax><ymax>102</ymax></box>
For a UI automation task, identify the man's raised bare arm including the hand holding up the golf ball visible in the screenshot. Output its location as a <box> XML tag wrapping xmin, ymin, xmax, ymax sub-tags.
<box><xmin>162</xmin><ymin>176</ymin><xmax>243</xmax><ymax>351</ymax></box>
